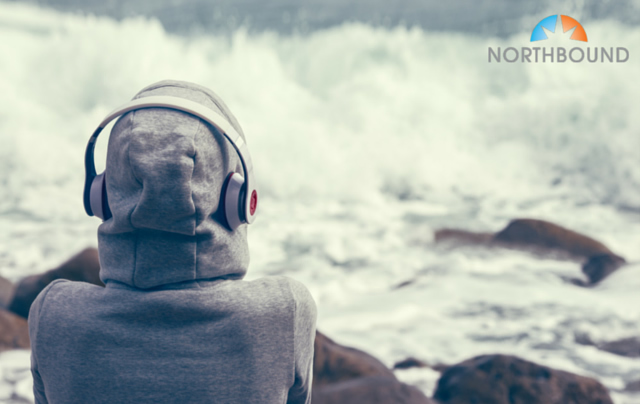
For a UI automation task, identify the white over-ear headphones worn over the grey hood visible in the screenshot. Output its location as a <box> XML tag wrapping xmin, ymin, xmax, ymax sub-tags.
<box><xmin>84</xmin><ymin>96</ymin><xmax>258</xmax><ymax>230</ymax></box>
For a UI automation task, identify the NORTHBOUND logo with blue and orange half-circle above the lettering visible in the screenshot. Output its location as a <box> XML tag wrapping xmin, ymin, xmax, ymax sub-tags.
<box><xmin>488</xmin><ymin>14</ymin><xmax>629</xmax><ymax>63</ymax></box>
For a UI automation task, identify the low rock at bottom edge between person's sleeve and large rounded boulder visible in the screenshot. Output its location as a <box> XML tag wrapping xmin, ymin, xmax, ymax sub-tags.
<box><xmin>311</xmin><ymin>376</ymin><xmax>435</xmax><ymax>404</ymax></box>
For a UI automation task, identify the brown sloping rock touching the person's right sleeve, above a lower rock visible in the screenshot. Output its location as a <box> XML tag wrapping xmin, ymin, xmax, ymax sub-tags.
<box><xmin>313</xmin><ymin>331</ymin><xmax>396</xmax><ymax>388</ymax></box>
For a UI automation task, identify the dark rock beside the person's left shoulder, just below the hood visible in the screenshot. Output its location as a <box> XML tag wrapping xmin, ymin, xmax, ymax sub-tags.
<box><xmin>9</xmin><ymin>248</ymin><xmax>104</xmax><ymax>318</ymax></box>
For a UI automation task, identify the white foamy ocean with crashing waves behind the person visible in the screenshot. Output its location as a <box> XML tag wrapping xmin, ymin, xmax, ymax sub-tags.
<box><xmin>0</xmin><ymin>0</ymin><xmax>640</xmax><ymax>404</ymax></box>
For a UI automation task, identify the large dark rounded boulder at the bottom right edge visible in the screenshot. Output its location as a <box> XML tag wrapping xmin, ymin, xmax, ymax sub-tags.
<box><xmin>433</xmin><ymin>355</ymin><xmax>613</xmax><ymax>404</ymax></box>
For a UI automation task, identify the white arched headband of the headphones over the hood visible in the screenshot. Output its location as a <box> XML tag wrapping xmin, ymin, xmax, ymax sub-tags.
<box><xmin>84</xmin><ymin>95</ymin><xmax>257</xmax><ymax>227</ymax></box>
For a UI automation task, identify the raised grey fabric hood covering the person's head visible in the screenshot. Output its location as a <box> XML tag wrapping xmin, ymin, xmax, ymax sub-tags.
<box><xmin>98</xmin><ymin>81</ymin><xmax>249</xmax><ymax>289</ymax></box>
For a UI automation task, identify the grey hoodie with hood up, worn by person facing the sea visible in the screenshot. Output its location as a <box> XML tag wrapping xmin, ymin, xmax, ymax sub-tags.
<box><xmin>29</xmin><ymin>81</ymin><xmax>316</xmax><ymax>404</ymax></box>
